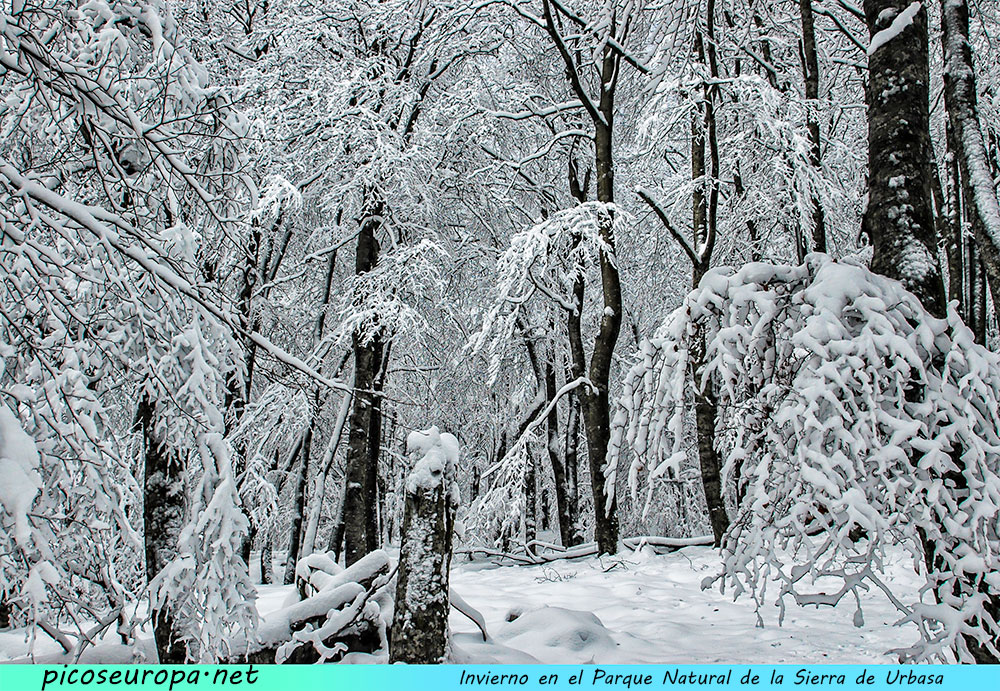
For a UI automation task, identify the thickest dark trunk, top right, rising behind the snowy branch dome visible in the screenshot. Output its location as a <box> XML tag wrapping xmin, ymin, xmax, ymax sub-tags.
<box><xmin>863</xmin><ymin>0</ymin><xmax>945</xmax><ymax>317</ymax></box>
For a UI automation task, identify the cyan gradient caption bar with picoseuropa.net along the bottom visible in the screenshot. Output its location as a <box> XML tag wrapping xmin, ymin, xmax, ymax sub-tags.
<box><xmin>0</xmin><ymin>665</ymin><xmax>988</xmax><ymax>691</ymax></box>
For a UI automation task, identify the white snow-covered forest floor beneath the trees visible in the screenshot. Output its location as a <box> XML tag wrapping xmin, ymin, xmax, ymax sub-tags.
<box><xmin>0</xmin><ymin>547</ymin><xmax>919</xmax><ymax>664</ymax></box>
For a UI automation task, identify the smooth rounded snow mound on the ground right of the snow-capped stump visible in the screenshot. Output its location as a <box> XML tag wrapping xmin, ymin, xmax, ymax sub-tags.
<box><xmin>496</xmin><ymin>607</ymin><xmax>618</xmax><ymax>663</ymax></box>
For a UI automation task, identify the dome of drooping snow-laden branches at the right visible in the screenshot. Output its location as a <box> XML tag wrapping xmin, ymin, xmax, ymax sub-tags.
<box><xmin>608</xmin><ymin>254</ymin><xmax>1000</xmax><ymax>660</ymax></box>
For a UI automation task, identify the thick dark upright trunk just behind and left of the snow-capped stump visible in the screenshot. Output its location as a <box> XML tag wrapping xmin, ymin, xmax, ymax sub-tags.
<box><xmin>343</xmin><ymin>197</ymin><xmax>384</xmax><ymax>566</ymax></box>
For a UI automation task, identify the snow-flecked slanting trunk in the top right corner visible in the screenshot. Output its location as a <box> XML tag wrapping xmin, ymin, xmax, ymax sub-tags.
<box><xmin>941</xmin><ymin>0</ymin><xmax>1000</xmax><ymax>328</ymax></box>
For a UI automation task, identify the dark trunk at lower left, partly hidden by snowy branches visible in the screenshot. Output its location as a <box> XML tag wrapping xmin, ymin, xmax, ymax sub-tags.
<box><xmin>136</xmin><ymin>393</ymin><xmax>187</xmax><ymax>664</ymax></box>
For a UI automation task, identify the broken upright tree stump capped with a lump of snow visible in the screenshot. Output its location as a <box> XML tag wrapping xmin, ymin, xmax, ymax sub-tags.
<box><xmin>389</xmin><ymin>427</ymin><xmax>458</xmax><ymax>663</ymax></box>
